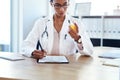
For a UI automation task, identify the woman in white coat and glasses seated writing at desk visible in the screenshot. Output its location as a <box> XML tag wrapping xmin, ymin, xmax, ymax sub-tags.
<box><xmin>22</xmin><ymin>0</ymin><xmax>93</xmax><ymax>59</ymax></box>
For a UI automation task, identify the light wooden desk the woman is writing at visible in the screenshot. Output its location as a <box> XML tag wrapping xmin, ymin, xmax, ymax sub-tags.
<box><xmin>0</xmin><ymin>47</ymin><xmax>119</xmax><ymax>80</ymax></box>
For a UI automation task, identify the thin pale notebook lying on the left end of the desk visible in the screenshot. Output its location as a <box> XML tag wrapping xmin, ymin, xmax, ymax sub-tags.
<box><xmin>0</xmin><ymin>52</ymin><xmax>24</xmax><ymax>61</ymax></box>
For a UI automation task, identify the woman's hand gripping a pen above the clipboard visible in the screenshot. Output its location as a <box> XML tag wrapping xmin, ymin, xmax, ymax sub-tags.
<box><xmin>32</xmin><ymin>50</ymin><xmax>46</xmax><ymax>59</ymax></box>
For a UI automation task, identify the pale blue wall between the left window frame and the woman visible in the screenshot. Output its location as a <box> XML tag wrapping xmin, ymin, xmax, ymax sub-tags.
<box><xmin>23</xmin><ymin>0</ymin><xmax>49</xmax><ymax>39</ymax></box>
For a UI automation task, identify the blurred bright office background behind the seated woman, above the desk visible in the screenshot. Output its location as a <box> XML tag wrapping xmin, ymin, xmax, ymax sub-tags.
<box><xmin>0</xmin><ymin>0</ymin><xmax>120</xmax><ymax>52</ymax></box>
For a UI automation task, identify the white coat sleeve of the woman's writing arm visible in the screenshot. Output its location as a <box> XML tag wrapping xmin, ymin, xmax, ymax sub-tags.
<box><xmin>22</xmin><ymin>20</ymin><xmax>42</xmax><ymax>57</ymax></box>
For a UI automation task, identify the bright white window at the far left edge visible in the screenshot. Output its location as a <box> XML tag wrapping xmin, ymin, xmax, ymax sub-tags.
<box><xmin>0</xmin><ymin>0</ymin><xmax>10</xmax><ymax>51</ymax></box>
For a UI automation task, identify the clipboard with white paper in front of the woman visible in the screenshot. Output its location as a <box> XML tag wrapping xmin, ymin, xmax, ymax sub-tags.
<box><xmin>37</xmin><ymin>56</ymin><xmax>69</xmax><ymax>64</ymax></box>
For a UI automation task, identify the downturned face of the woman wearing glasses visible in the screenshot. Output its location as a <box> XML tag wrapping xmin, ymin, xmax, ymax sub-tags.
<box><xmin>51</xmin><ymin>0</ymin><xmax>69</xmax><ymax>17</ymax></box>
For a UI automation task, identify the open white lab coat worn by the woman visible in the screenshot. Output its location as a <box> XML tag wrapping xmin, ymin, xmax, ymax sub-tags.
<box><xmin>22</xmin><ymin>15</ymin><xmax>93</xmax><ymax>57</ymax></box>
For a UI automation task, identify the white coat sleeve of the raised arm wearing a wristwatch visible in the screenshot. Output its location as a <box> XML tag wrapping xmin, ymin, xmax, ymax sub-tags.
<box><xmin>77</xmin><ymin>20</ymin><xmax>93</xmax><ymax>56</ymax></box>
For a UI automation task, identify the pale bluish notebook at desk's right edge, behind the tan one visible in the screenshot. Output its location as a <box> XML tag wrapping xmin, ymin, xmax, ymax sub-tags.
<box><xmin>98</xmin><ymin>50</ymin><xmax>120</xmax><ymax>59</ymax></box>
